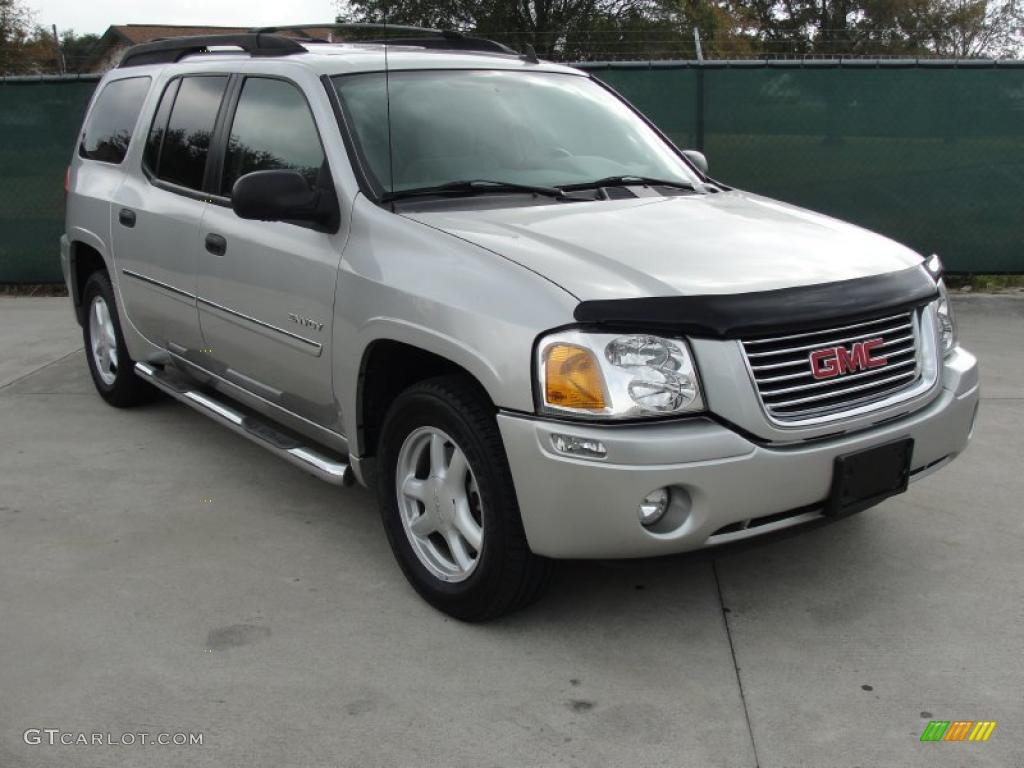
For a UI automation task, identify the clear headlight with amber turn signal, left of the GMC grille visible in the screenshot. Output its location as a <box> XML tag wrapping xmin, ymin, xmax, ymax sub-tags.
<box><xmin>537</xmin><ymin>331</ymin><xmax>703</xmax><ymax>419</ymax></box>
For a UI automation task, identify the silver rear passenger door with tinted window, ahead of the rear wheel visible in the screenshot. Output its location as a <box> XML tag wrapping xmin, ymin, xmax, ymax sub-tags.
<box><xmin>111</xmin><ymin>75</ymin><xmax>229</xmax><ymax>356</ymax></box>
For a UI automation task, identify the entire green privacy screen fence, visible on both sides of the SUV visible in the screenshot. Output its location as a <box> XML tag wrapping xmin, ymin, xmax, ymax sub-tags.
<box><xmin>0</xmin><ymin>60</ymin><xmax>1024</xmax><ymax>283</ymax></box>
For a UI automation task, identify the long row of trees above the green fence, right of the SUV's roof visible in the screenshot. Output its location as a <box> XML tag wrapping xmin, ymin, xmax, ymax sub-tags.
<box><xmin>338</xmin><ymin>0</ymin><xmax>1024</xmax><ymax>60</ymax></box>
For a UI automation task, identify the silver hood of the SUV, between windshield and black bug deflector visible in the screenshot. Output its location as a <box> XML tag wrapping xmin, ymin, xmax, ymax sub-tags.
<box><xmin>406</xmin><ymin>191</ymin><xmax>922</xmax><ymax>301</ymax></box>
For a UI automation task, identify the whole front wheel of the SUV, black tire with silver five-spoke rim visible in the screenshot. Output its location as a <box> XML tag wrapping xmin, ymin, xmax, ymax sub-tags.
<box><xmin>377</xmin><ymin>377</ymin><xmax>551</xmax><ymax>621</ymax></box>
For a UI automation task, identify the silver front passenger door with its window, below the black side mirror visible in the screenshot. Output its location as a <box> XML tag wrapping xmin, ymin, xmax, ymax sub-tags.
<box><xmin>197</xmin><ymin>76</ymin><xmax>345</xmax><ymax>427</ymax></box>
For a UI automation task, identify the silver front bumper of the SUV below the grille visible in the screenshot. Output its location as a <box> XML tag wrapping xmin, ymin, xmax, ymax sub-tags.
<box><xmin>498</xmin><ymin>347</ymin><xmax>978</xmax><ymax>558</ymax></box>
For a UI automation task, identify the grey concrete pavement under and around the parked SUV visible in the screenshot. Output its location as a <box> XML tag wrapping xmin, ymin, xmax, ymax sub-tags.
<box><xmin>0</xmin><ymin>296</ymin><xmax>1024</xmax><ymax>768</ymax></box>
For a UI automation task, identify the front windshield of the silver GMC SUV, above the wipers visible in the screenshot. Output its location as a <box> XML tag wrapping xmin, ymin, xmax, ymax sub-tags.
<box><xmin>334</xmin><ymin>70</ymin><xmax>697</xmax><ymax>198</ymax></box>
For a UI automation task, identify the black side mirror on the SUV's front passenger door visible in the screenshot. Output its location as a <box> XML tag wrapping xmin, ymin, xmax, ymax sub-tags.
<box><xmin>231</xmin><ymin>166</ymin><xmax>340</xmax><ymax>231</ymax></box>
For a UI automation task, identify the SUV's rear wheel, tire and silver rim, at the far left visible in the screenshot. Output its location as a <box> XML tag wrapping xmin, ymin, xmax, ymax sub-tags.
<box><xmin>82</xmin><ymin>271</ymin><xmax>157</xmax><ymax>408</ymax></box>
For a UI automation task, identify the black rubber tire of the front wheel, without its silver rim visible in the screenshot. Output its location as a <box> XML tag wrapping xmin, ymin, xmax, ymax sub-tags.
<box><xmin>377</xmin><ymin>376</ymin><xmax>552</xmax><ymax>622</ymax></box>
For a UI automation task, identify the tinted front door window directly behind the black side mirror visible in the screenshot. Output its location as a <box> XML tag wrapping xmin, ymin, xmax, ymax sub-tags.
<box><xmin>220</xmin><ymin>78</ymin><xmax>324</xmax><ymax>195</ymax></box>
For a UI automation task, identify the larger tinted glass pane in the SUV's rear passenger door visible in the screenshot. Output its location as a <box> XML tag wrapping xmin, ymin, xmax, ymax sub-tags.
<box><xmin>153</xmin><ymin>76</ymin><xmax>227</xmax><ymax>189</ymax></box>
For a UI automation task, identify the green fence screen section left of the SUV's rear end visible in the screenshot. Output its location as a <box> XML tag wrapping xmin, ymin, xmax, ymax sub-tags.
<box><xmin>0</xmin><ymin>80</ymin><xmax>96</xmax><ymax>283</ymax></box>
